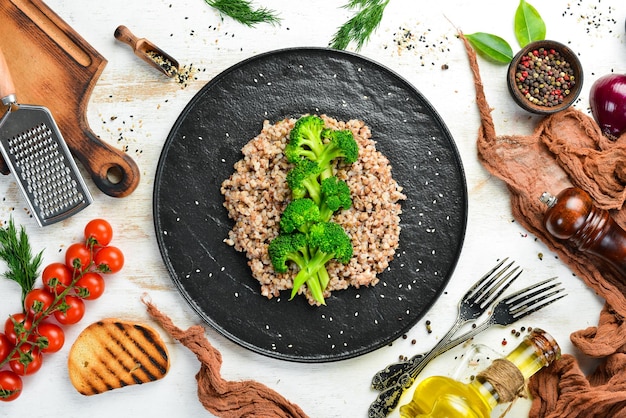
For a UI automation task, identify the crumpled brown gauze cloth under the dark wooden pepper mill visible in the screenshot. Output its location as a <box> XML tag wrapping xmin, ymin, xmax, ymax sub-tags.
<box><xmin>460</xmin><ymin>34</ymin><xmax>626</xmax><ymax>418</ymax></box>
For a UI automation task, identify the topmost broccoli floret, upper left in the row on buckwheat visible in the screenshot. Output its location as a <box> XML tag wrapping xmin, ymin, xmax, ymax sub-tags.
<box><xmin>285</xmin><ymin>115</ymin><xmax>324</xmax><ymax>163</ymax></box>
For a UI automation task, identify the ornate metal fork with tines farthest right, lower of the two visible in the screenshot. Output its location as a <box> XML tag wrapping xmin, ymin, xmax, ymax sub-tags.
<box><xmin>372</xmin><ymin>277</ymin><xmax>566</xmax><ymax>391</ymax></box>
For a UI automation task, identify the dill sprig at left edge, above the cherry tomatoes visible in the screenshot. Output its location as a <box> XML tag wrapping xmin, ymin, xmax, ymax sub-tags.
<box><xmin>0</xmin><ymin>218</ymin><xmax>43</xmax><ymax>304</ymax></box>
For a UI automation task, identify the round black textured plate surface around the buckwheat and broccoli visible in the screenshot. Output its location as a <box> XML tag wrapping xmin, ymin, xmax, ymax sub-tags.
<box><xmin>154</xmin><ymin>48</ymin><xmax>467</xmax><ymax>362</ymax></box>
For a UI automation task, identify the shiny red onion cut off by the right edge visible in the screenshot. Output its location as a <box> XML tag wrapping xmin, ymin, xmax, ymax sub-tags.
<box><xmin>589</xmin><ymin>74</ymin><xmax>626</xmax><ymax>138</ymax></box>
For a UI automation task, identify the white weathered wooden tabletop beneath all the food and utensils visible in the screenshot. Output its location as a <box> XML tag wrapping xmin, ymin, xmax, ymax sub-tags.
<box><xmin>0</xmin><ymin>0</ymin><xmax>626</xmax><ymax>418</ymax></box>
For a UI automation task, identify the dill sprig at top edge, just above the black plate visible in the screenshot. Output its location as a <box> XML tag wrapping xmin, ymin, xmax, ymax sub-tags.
<box><xmin>330</xmin><ymin>0</ymin><xmax>389</xmax><ymax>51</ymax></box>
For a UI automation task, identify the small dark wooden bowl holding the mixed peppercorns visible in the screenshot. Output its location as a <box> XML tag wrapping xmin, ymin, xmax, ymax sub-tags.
<box><xmin>507</xmin><ymin>40</ymin><xmax>583</xmax><ymax>115</ymax></box>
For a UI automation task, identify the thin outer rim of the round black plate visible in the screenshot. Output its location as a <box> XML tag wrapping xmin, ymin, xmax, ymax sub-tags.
<box><xmin>152</xmin><ymin>46</ymin><xmax>469</xmax><ymax>363</ymax></box>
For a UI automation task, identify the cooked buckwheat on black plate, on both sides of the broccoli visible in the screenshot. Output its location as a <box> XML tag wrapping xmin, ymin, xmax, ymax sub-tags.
<box><xmin>221</xmin><ymin>115</ymin><xmax>406</xmax><ymax>304</ymax></box>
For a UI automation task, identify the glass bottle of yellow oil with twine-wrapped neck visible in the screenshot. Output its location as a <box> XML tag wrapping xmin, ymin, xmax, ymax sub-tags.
<box><xmin>400</xmin><ymin>329</ymin><xmax>561</xmax><ymax>418</ymax></box>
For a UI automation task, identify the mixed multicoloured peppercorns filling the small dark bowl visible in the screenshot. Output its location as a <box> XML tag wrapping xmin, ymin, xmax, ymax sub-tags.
<box><xmin>515</xmin><ymin>48</ymin><xmax>576</xmax><ymax>107</ymax></box>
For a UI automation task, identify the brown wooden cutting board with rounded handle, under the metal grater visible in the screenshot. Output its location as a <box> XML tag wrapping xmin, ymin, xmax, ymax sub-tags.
<box><xmin>0</xmin><ymin>0</ymin><xmax>139</xmax><ymax>197</ymax></box>
